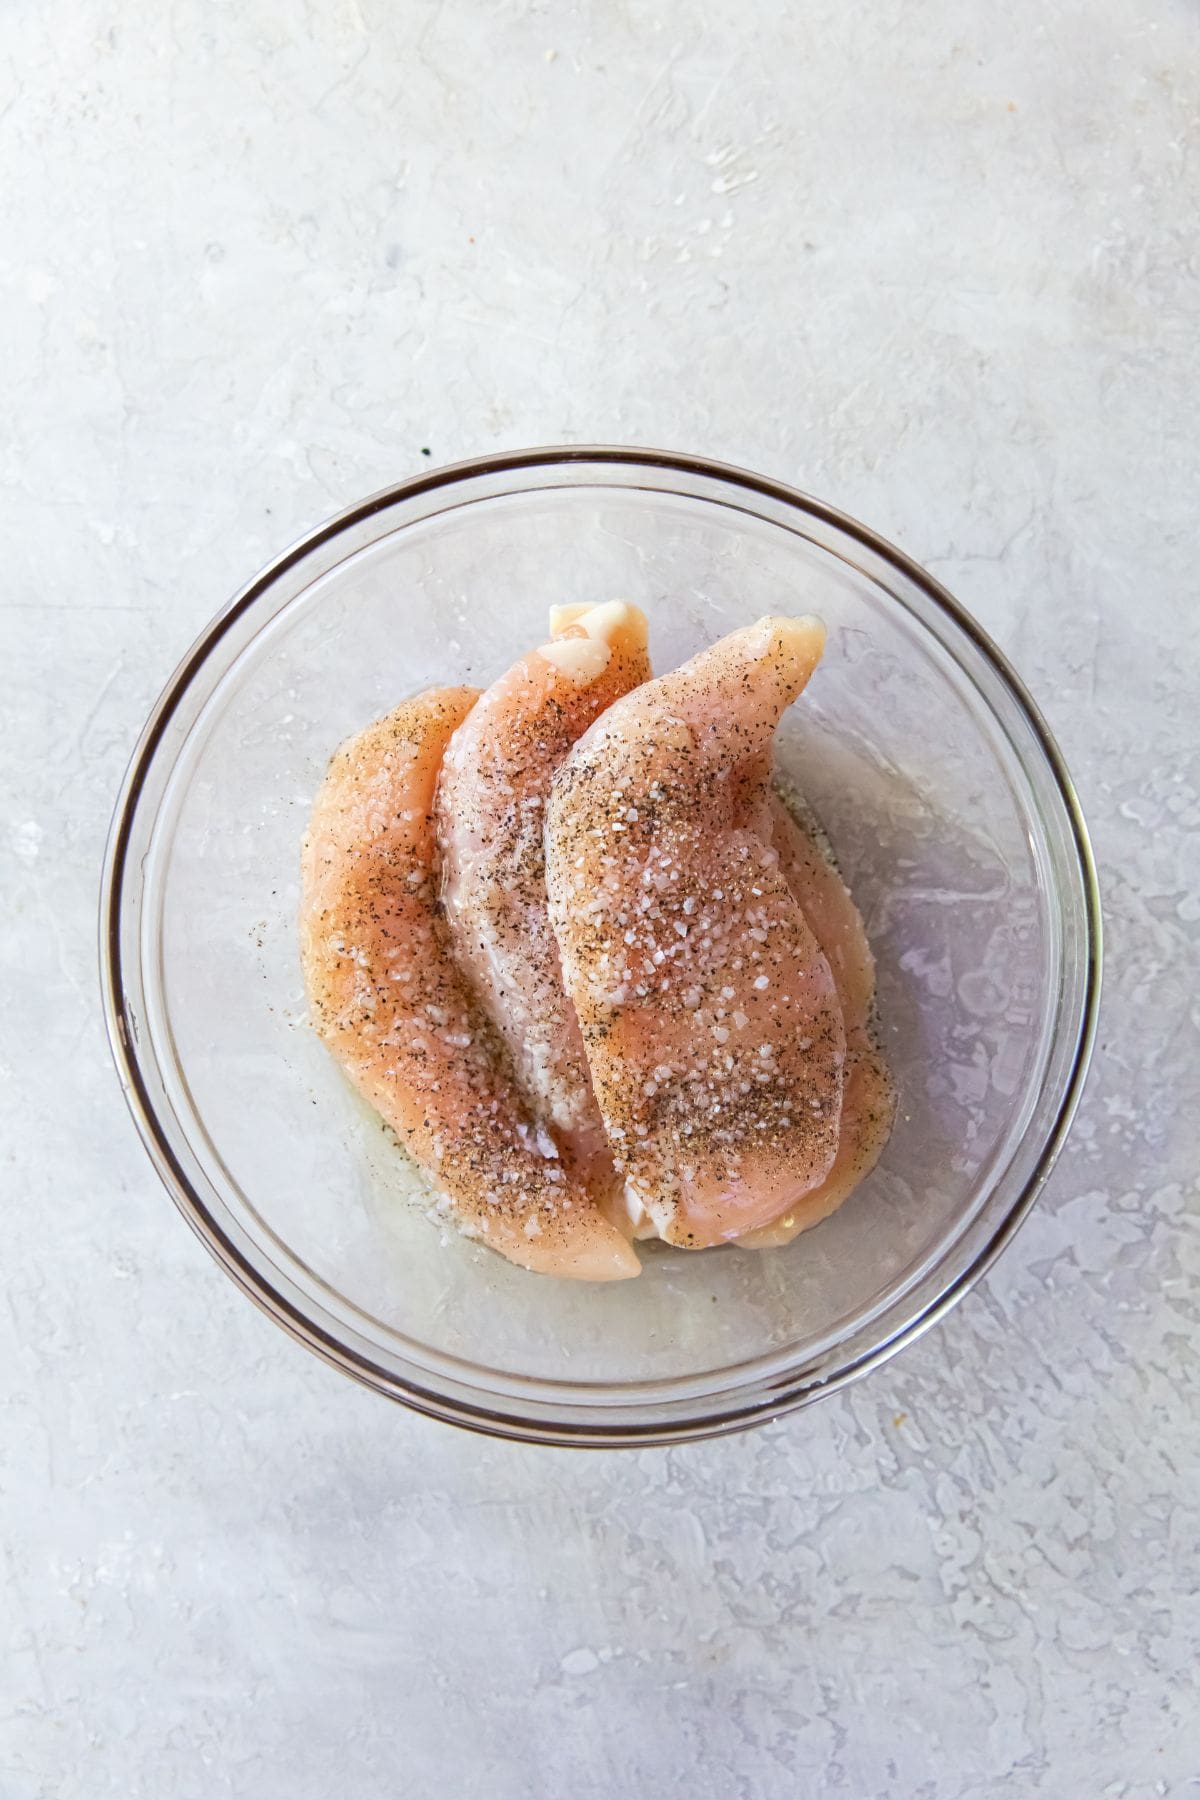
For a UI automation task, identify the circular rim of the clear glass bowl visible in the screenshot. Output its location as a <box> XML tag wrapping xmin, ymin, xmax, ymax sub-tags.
<box><xmin>99</xmin><ymin>445</ymin><xmax>1103</xmax><ymax>1447</ymax></box>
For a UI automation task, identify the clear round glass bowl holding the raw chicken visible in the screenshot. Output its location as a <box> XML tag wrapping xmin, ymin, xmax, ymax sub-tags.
<box><xmin>101</xmin><ymin>448</ymin><xmax>1099</xmax><ymax>1444</ymax></box>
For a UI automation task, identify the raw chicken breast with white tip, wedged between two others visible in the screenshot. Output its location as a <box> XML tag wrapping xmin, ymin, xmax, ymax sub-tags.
<box><xmin>437</xmin><ymin>599</ymin><xmax>649</xmax><ymax>1188</ymax></box>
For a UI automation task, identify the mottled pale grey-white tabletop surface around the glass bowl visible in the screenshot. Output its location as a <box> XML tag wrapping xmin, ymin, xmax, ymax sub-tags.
<box><xmin>0</xmin><ymin>0</ymin><xmax>1200</xmax><ymax>1800</ymax></box>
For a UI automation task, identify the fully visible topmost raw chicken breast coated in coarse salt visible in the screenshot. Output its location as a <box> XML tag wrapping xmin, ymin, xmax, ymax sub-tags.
<box><xmin>547</xmin><ymin>619</ymin><xmax>846</xmax><ymax>1247</ymax></box>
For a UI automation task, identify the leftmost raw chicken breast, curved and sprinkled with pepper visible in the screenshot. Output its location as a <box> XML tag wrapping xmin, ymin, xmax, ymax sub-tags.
<box><xmin>300</xmin><ymin>688</ymin><xmax>639</xmax><ymax>1282</ymax></box>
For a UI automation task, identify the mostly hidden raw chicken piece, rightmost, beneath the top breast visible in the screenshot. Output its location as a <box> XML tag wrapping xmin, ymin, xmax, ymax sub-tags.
<box><xmin>738</xmin><ymin>796</ymin><xmax>896</xmax><ymax>1249</ymax></box>
